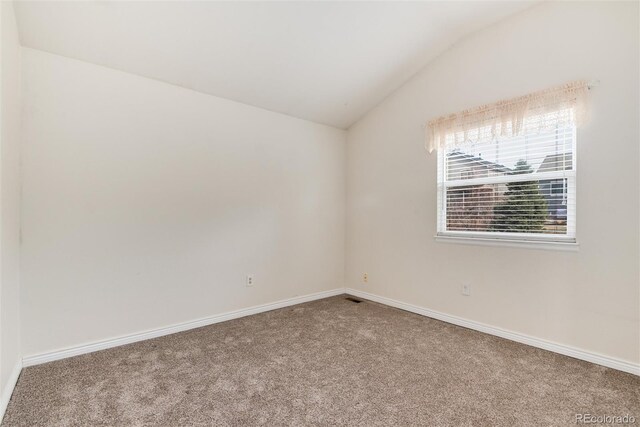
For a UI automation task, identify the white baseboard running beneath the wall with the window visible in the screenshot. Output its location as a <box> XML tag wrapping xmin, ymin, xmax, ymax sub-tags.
<box><xmin>345</xmin><ymin>288</ymin><xmax>640</xmax><ymax>375</ymax></box>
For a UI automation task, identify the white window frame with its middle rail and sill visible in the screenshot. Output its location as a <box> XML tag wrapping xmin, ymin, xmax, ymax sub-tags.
<box><xmin>435</xmin><ymin>125</ymin><xmax>578</xmax><ymax>251</ymax></box>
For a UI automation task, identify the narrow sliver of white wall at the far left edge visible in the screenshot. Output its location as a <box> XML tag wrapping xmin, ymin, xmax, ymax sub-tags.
<box><xmin>0</xmin><ymin>1</ymin><xmax>21</xmax><ymax>408</ymax></box>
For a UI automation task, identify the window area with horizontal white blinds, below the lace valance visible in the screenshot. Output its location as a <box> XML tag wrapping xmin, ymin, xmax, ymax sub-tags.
<box><xmin>438</xmin><ymin>109</ymin><xmax>576</xmax><ymax>241</ymax></box>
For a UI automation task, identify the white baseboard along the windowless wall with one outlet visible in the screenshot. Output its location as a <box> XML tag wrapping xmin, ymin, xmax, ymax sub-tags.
<box><xmin>22</xmin><ymin>288</ymin><xmax>344</xmax><ymax>367</ymax></box>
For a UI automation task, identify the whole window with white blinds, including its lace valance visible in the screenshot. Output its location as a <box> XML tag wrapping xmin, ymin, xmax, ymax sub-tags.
<box><xmin>426</xmin><ymin>81</ymin><xmax>589</xmax><ymax>242</ymax></box>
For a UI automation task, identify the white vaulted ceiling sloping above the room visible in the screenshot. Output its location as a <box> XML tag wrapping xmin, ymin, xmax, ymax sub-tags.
<box><xmin>16</xmin><ymin>1</ymin><xmax>532</xmax><ymax>128</ymax></box>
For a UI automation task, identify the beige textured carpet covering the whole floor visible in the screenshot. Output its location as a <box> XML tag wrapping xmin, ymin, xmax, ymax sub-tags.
<box><xmin>3</xmin><ymin>296</ymin><xmax>640</xmax><ymax>427</ymax></box>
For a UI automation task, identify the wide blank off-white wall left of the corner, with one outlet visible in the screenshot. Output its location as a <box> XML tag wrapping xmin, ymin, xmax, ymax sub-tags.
<box><xmin>22</xmin><ymin>49</ymin><xmax>346</xmax><ymax>356</ymax></box>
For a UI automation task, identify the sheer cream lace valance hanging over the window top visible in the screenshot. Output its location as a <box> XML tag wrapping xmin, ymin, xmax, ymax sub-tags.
<box><xmin>426</xmin><ymin>81</ymin><xmax>589</xmax><ymax>153</ymax></box>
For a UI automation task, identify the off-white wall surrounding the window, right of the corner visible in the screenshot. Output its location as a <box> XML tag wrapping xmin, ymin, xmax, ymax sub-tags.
<box><xmin>346</xmin><ymin>2</ymin><xmax>640</xmax><ymax>363</ymax></box>
